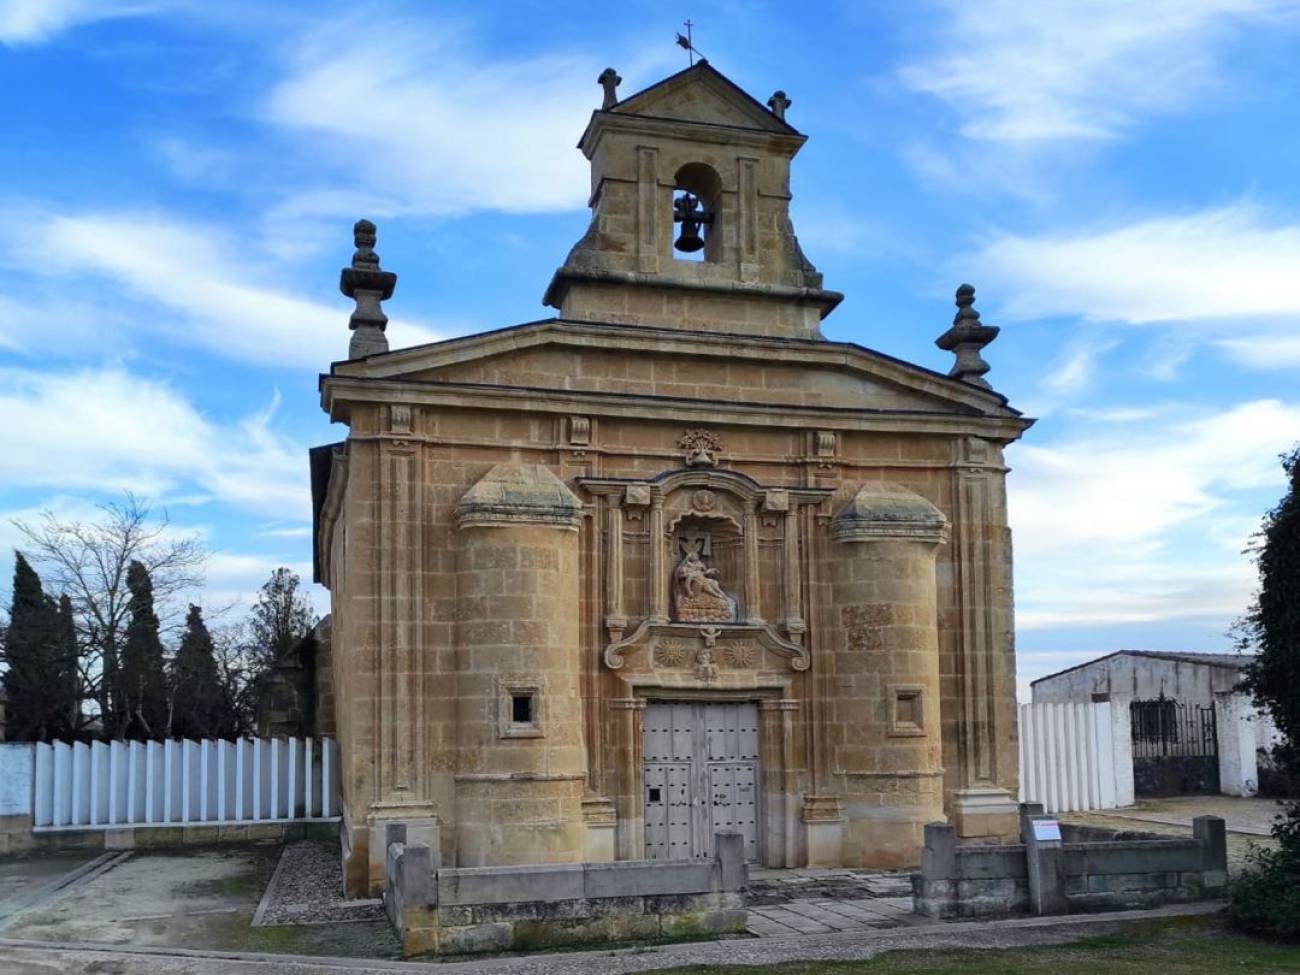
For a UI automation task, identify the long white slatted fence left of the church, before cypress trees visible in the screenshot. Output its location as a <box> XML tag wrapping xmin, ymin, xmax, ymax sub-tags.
<box><xmin>33</xmin><ymin>738</ymin><xmax>339</xmax><ymax>829</ymax></box>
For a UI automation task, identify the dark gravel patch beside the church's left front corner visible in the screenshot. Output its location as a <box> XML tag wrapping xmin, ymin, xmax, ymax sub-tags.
<box><xmin>252</xmin><ymin>840</ymin><xmax>384</xmax><ymax>927</ymax></box>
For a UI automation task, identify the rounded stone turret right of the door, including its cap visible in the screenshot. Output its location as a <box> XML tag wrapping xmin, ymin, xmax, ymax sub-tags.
<box><xmin>826</xmin><ymin>485</ymin><xmax>948</xmax><ymax>867</ymax></box>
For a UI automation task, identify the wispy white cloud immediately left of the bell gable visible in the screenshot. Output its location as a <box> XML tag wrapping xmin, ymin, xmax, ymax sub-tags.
<box><xmin>267</xmin><ymin>20</ymin><xmax>608</xmax><ymax>216</ymax></box>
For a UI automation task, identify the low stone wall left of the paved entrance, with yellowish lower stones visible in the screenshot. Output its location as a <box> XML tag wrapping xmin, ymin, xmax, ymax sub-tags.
<box><xmin>384</xmin><ymin>833</ymin><xmax>749</xmax><ymax>957</ymax></box>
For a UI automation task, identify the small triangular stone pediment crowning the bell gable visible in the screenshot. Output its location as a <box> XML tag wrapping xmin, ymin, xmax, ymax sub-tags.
<box><xmin>608</xmin><ymin>61</ymin><xmax>797</xmax><ymax>135</ymax></box>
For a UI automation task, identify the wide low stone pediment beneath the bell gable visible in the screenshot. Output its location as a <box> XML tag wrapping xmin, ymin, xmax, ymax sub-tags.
<box><xmin>333</xmin><ymin>320</ymin><xmax>1019</xmax><ymax>417</ymax></box>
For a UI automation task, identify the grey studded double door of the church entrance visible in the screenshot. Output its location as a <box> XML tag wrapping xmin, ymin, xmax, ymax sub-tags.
<box><xmin>641</xmin><ymin>701</ymin><xmax>759</xmax><ymax>862</ymax></box>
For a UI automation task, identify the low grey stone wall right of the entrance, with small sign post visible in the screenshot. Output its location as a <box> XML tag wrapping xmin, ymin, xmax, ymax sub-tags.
<box><xmin>913</xmin><ymin>816</ymin><xmax>1227</xmax><ymax>918</ymax></box>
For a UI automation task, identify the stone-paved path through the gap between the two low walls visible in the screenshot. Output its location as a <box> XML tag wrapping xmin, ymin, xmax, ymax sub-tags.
<box><xmin>746</xmin><ymin>870</ymin><xmax>928</xmax><ymax>937</ymax></box>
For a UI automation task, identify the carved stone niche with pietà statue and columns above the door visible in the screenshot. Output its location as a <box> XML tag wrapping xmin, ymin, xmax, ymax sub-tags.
<box><xmin>579</xmin><ymin>468</ymin><xmax>828</xmax><ymax>686</ymax></box>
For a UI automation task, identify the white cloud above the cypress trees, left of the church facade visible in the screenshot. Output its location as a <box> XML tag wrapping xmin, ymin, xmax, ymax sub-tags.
<box><xmin>0</xmin><ymin>369</ymin><xmax>311</xmax><ymax>521</ymax></box>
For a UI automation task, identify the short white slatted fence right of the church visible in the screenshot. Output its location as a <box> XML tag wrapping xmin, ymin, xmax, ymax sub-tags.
<box><xmin>1021</xmin><ymin>702</ymin><xmax>1134</xmax><ymax>813</ymax></box>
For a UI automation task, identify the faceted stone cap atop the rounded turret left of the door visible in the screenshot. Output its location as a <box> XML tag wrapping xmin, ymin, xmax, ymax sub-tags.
<box><xmin>456</xmin><ymin>464</ymin><xmax>582</xmax><ymax>532</ymax></box>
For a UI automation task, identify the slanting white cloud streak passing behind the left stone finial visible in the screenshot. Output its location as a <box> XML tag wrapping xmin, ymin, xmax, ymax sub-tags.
<box><xmin>10</xmin><ymin>212</ymin><xmax>438</xmax><ymax>369</ymax></box>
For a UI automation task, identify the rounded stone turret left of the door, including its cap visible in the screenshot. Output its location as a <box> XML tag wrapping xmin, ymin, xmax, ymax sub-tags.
<box><xmin>447</xmin><ymin>464</ymin><xmax>586</xmax><ymax>867</ymax></box>
